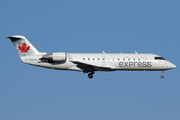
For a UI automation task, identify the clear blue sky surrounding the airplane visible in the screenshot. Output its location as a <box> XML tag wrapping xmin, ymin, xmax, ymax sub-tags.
<box><xmin>0</xmin><ymin>0</ymin><xmax>180</xmax><ymax>120</ymax></box>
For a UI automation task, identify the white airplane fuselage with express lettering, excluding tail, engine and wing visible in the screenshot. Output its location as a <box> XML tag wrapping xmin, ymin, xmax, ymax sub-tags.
<box><xmin>20</xmin><ymin>53</ymin><xmax>176</xmax><ymax>71</ymax></box>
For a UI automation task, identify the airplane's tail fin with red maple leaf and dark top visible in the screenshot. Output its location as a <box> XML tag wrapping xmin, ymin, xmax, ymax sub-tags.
<box><xmin>7</xmin><ymin>36</ymin><xmax>39</xmax><ymax>57</ymax></box>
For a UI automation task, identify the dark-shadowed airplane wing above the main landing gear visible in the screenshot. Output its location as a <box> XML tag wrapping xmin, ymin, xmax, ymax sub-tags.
<box><xmin>71</xmin><ymin>61</ymin><xmax>113</xmax><ymax>73</ymax></box>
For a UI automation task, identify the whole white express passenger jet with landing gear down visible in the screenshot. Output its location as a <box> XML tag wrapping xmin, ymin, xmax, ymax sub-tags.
<box><xmin>7</xmin><ymin>35</ymin><xmax>176</xmax><ymax>79</ymax></box>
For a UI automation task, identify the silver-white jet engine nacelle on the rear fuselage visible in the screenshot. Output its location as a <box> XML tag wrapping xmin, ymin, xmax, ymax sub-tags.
<box><xmin>42</xmin><ymin>52</ymin><xmax>67</xmax><ymax>62</ymax></box>
